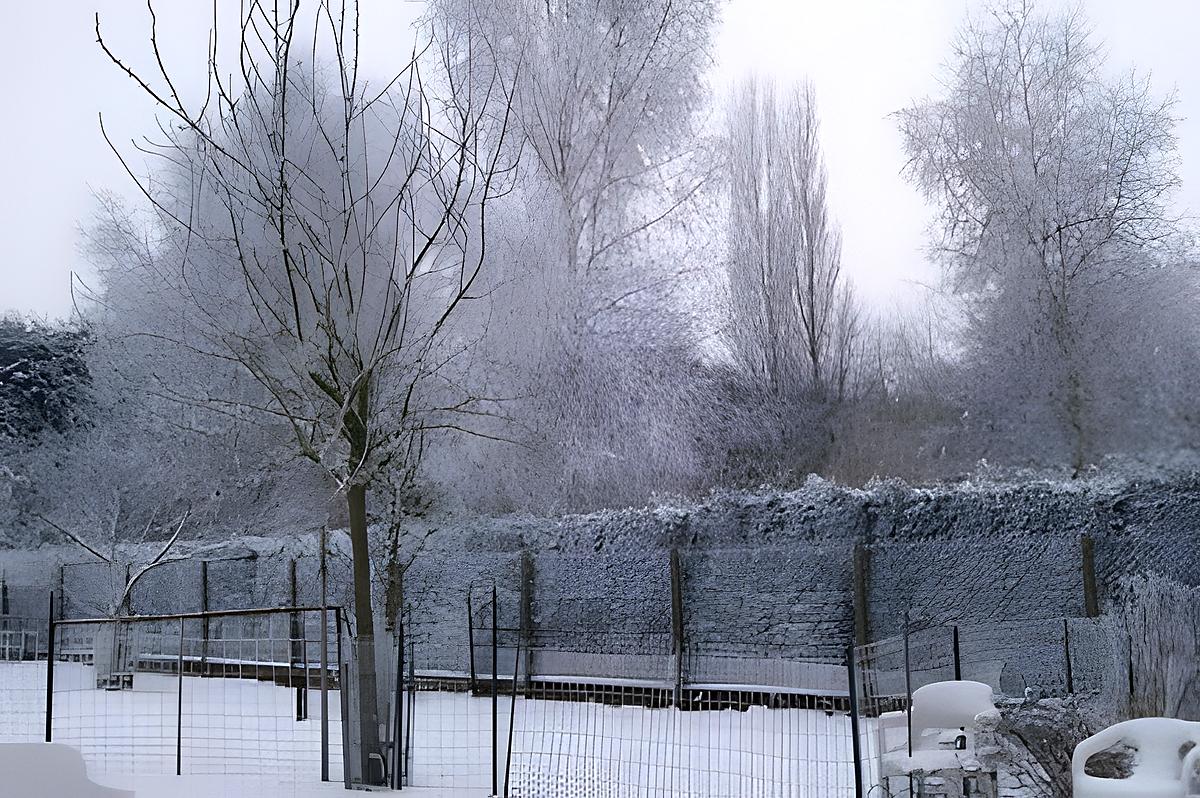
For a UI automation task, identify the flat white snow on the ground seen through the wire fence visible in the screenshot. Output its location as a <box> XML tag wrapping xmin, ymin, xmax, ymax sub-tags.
<box><xmin>0</xmin><ymin>662</ymin><xmax>868</xmax><ymax>798</ymax></box>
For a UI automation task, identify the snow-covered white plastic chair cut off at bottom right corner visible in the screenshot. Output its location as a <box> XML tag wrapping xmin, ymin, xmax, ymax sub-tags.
<box><xmin>1070</xmin><ymin>718</ymin><xmax>1200</xmax><ymax>798</ymax></box>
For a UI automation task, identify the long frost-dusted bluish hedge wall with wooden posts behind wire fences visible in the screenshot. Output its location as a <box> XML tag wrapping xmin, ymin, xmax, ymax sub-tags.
<box><xmin>0</xmin><ymin>473</ymin><xmax>1200</xmax><ymax>670</ymax></box>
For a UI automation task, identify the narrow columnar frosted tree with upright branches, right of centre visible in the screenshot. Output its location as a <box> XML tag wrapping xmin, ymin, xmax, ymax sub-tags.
<box><xmin>727</xmin><ymin>78</ymin><xmax>862</xmax><ymax>468</ymax></box>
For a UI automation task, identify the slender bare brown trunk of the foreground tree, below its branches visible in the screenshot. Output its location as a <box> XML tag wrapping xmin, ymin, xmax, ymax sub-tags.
<box><xmin>346</xmin><ymin>484</ymin><xmax>383</xmax><ymax>784</ymax></box>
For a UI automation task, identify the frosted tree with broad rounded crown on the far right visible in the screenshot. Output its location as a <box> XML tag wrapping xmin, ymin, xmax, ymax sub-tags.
<box><xmin>898</xmin><ymin>0</ymin><xmax>1180</xmax><ymax>473</ymax></box>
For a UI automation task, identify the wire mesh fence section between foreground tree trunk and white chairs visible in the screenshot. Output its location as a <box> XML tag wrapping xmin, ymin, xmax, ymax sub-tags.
<box><xmin>369</xmin><ymin>590</ymin><xmax>854</xmax><ymax>798</ymax></box>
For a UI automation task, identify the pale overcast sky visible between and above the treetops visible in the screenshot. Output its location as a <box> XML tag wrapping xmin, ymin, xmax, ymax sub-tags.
<box><xmin>0</xmin><ymin>0</ymin><xmax>1200</xmax><ymax>317</ymax></box>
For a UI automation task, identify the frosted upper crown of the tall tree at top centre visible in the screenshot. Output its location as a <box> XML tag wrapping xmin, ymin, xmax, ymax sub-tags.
<box><xmin>434</xmin><ymin>0</ymin><xmax>716</xmax><ymax>286</ymax></box>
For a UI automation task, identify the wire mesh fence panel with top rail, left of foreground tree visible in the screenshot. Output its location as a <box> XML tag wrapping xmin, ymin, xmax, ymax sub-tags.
<box><xmin>39</xmin><ymin>607</ymin><xmax>342</xmax><ymax>781</ymax></box>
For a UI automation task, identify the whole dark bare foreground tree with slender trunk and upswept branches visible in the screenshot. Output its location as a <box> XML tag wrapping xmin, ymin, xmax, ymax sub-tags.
<box><xmin>88</xmin><ymin>0</ymin><xmax>509</xmax><ymax>779</ymax></box>
